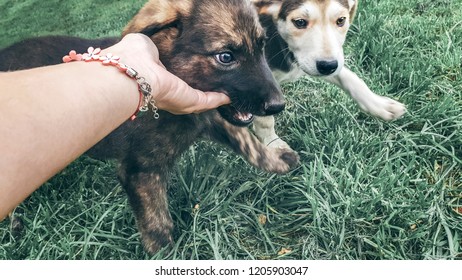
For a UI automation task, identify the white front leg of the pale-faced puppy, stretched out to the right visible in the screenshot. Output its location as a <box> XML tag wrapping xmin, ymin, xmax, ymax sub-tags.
<box><xmin>323</xmin><ymin>67</ymin><xmax>406</xmax><ymax>121</ymax></box>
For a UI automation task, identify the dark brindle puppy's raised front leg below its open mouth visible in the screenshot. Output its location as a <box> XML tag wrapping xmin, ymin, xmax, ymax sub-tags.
<box><xmin>208</xmin><ymin>116</ymin><xmax>299</xmax><ymax>173</ymax></box>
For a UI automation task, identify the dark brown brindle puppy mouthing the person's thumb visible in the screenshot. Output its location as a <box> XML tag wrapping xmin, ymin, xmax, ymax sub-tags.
<box><xmin>0</xmin><ymin>0</ymin><xmax>298</xmax><ymax>253</ymax></box>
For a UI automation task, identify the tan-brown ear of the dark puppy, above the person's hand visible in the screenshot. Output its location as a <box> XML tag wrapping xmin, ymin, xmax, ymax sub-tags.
<box><xmin>122</xmin><ymin>0</ymin><xmax>192</xmax><ymax>36</ymax></box>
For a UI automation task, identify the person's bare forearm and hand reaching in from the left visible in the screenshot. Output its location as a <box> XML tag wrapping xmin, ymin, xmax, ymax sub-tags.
<box><xmin>0</xmin><ymin>35</ymin><xmax>229</xmax><ymax>220</ymax></box>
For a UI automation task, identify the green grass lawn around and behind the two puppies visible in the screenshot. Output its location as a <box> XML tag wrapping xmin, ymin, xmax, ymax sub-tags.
<box><xmin>0</xmin><ymin>0</ymin><xmax>462</xmax><ymax>259</ymax></box>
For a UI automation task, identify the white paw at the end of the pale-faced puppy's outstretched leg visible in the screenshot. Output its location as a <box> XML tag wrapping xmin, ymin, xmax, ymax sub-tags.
<box><xmin>366</xmin><ymin>95</ymin><xmax>406</xmax><ymax>121</ymax></box>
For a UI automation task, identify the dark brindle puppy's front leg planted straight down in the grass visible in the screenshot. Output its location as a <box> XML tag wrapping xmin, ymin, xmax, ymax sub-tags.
<box><xmin>119</xmin><ymin>166</ymin><xmax>173</xmax><ymax>254</ymax></box>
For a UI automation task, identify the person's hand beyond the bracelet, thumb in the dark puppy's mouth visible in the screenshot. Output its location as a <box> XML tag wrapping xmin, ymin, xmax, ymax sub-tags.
<box><xmin>103</xmin><ymin>34</ymin><xmax>230</xmax><ymax>114</ymax></box>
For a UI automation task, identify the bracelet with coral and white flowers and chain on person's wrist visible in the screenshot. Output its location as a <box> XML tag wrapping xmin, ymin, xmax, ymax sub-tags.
<box><xmin>63</xmin><ymin>47</ymin><xmax>159</xmax><ymax>120</ymax></box>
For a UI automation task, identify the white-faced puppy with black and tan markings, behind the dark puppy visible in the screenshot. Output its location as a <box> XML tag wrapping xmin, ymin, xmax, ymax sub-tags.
<box><xmin>252</xmin><ymin>0</ymin><xmax>406</xmax><ymax>147</ymax></box>
